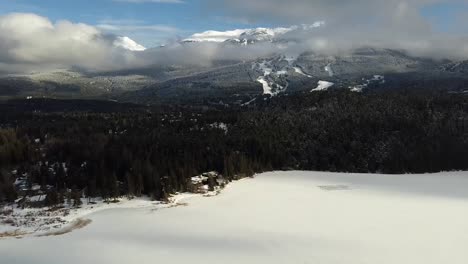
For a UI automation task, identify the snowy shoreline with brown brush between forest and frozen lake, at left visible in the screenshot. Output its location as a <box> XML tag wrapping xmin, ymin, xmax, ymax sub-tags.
<box><xmin>0</xmin><ymin>183</ymin><xmax>227</xmax><ymax>239</ymax></box>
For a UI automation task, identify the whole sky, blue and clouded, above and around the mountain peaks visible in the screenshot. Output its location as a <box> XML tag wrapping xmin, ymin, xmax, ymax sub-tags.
<box><xmin>0</xmin><ymin>0</ymin><xmax>468</xmax><ymax>74</ymax></box>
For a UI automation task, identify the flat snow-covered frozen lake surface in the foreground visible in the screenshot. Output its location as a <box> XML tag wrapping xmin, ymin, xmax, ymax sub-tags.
<box><xmin>0</xmin><ymin>172</ymin><xmax>468</xmax><ymax>264</ymax></box>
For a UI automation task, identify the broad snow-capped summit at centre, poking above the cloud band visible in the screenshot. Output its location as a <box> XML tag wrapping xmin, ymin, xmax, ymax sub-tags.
<box><xmin>183</xmin><ymin>22</ymin><xmax>325</xmax><ymax>44</ymax></box>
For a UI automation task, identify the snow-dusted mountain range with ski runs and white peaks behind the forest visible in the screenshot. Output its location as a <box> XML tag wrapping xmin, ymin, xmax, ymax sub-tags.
<box><xmin>0</xmin><ymin>25</ymin><xmax>468</xmax><ymax>104</ymax></box>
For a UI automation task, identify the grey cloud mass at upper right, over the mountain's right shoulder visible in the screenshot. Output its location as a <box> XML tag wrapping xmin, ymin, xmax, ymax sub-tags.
<box><xmin>200</xmin><ymin>0</ymin><xmax>468</xmax><ymax>59</ymax></box>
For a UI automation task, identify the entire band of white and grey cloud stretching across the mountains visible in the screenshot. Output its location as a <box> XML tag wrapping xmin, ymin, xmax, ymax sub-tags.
<box><xmin>0</xmin><ymin>0</ymin><xmax>468</xmax><ymax>76</ymax></box>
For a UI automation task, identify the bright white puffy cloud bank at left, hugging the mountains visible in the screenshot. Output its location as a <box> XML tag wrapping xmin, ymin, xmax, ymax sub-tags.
<box><xmin>0</xmin><ymin>13</ymin><xmax>224</xmax><ymax>73</ymax></box>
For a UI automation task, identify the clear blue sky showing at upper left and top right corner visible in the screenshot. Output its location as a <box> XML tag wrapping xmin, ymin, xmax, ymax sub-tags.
<box><xmin>0</xmin><ymin>0</ymin><xmax>468</xmax><ymax>46</ymax></box>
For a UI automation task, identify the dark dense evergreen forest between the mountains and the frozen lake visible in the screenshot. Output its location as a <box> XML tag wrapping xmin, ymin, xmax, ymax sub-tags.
<box><xmin>0</xmin><ymin>90</ymin><xmax>468</xmax><ymax>205</ymax></box>
